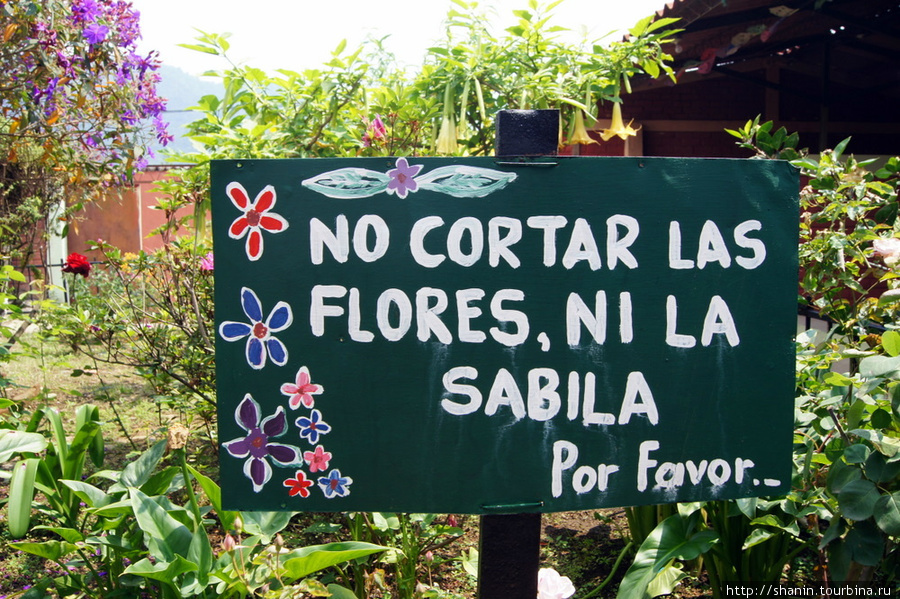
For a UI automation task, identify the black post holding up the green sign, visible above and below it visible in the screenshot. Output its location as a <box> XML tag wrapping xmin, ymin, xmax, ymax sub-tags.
<box><xmin>478</xmin><ymin>110</ymin><xmax>559</xmax><ymax>599</ymax></box>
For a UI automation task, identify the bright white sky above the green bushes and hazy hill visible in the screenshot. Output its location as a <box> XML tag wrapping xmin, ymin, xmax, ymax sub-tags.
<box><xmin>132</xmin><ymin>0</ymin><xmax>665</xmax><ymax>75</ymax></box>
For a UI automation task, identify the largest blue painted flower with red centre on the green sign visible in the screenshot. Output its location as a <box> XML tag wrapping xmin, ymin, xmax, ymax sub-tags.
<box><xmin>219</xmin><ymin>287</ymin><xmax>294</xmax><ymax>370</ymax></box>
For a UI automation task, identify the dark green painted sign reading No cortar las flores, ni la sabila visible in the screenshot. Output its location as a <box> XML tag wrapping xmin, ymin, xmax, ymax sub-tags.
<box><xmin>212</xmin><ymin>157</ymin><xmax>798</xmax><ymax>513</ymax></box>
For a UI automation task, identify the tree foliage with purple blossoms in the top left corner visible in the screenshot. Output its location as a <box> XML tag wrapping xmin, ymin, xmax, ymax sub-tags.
<box><xmin>0</xmin><ymin>0</ymin><xmax>171</xmax><ymax>253</ymax></box>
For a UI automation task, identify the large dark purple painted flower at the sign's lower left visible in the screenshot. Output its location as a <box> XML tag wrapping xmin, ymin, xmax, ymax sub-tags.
<box><xmin>222</xmin><ymin>393</ymin><xmax>303</xmax><ymax>493</ymax></box>
